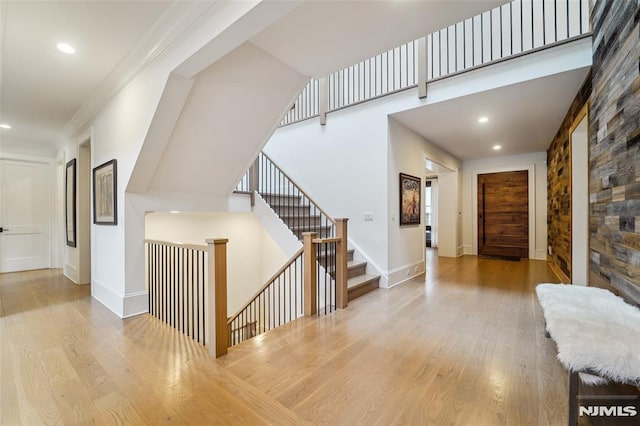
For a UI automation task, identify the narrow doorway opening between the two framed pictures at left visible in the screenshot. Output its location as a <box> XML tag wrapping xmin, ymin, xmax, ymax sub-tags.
<box><xmin>78</xmin><ymin>138</ymin><xmax>92</xmax><ymax>284</ymax></box>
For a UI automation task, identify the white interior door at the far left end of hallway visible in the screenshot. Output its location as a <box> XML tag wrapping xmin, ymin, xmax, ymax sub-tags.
<box><xmin>0</xmin><ymin>159</ymin><xmax>51</xmax><ymax>272</ymax></box>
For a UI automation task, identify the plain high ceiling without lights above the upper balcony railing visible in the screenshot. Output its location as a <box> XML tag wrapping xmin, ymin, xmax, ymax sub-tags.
<box><xmin>251</xmin><ymin>0</ymin><xmax>508</xmax><ymax>78</ymax></box>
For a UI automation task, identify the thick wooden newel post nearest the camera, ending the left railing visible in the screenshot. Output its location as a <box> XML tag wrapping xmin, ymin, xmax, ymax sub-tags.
<box><xmin>206</xmin><ymin>238</ymin><xmax>229</xmax><ymax>358</ymax></box>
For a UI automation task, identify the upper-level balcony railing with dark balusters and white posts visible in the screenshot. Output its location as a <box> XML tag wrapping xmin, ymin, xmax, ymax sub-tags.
<box><xmin>280</xmin><ymin>0</ymin><xmax>591</xmax><ymax>126</ymax></box>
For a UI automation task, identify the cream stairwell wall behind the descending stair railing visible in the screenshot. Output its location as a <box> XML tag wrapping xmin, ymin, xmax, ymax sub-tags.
<box><xmin>145</xmin><ymin>212</ymin><xmax>287</xmax><ymax>316</ymax></box>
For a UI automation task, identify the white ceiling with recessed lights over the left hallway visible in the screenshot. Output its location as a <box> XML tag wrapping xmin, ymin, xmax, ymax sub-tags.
<box><xmin>0</xmin><ymin>1</ymin><xmax>184</xmax><ymax>146</ymax></box>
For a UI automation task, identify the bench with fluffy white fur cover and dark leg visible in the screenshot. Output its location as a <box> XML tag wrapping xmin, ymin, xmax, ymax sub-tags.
<box><xmin>536</xmin><ymin>284</ymin><xmax>640</xmax><ymax>425</ymax></box>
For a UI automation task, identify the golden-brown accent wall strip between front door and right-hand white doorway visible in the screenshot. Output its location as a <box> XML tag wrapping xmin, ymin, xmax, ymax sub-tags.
<box><xmin>547</xmin><ymin>80</ymin><xmax>591</xmax><ymax>281</ymax></box>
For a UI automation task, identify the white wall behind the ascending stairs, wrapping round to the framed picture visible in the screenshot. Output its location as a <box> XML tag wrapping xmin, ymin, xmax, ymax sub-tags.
<box><xmin>264</xmin><ymin>96</ymin><xmax>460</xmax><ymax>286</ymax></box>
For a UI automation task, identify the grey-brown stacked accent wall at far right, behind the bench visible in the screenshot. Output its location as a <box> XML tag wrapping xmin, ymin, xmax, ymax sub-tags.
<box><xmin>589</xmin><ymin>0</ymin><xmax>640</xmax><ymax>303</ymax></box>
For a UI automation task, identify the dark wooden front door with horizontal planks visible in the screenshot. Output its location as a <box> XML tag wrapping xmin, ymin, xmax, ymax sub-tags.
<box><xmin>478</xmin><ymin>170</ymin><xmax>529</xmax><ymax>258</ymax></box>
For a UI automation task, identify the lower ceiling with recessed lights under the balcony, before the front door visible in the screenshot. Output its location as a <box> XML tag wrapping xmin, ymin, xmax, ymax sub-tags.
<box><xmin>392</xmin><ymin>67</ymin><xmax>589</xmax><ymax>160</ymax></box>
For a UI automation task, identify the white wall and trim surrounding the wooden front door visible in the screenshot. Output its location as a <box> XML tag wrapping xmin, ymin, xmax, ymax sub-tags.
<box><xmin>462</xmin><ymin>152</ymin><xmax>547</xmax><ymax>260</ymax></box>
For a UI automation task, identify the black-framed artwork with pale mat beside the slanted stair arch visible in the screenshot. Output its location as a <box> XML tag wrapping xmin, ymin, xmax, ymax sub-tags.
<box><xmin>93</xmin><ymin>160</ymin><xmax>118</xmax><ymax>225</ymax></box>
